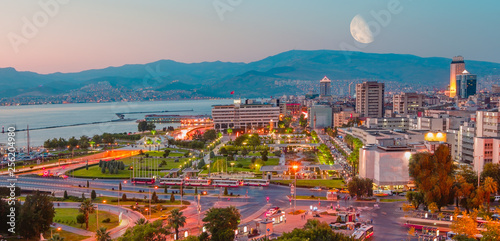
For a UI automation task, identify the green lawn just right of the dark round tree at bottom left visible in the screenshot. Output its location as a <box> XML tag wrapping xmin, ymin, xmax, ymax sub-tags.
<box><xmin>54</xmin><ymin>206</ymin><xmax>119</xmax><ymax>232</ymax></box>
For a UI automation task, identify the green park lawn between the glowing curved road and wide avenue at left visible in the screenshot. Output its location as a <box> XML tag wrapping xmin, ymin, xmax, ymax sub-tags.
<box><xmin>66</xmin><ymin>154</ymin><xmax>188</xmax><ymax>178</ymax></box>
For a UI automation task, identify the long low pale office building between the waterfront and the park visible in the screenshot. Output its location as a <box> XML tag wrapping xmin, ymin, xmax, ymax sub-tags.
<box><xmin>212</xmin><ymin>100</ymin><xmax>280</xmax><ymax>132</ymax></box>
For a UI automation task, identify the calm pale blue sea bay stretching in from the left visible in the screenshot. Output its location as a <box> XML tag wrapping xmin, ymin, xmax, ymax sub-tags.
<box><xmin>0</xmin><ymin>99</ymin><xmax>233</xmax><ymax>149</ymax></box>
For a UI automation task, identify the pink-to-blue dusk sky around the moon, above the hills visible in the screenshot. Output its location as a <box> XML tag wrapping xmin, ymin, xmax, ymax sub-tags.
<box><xmin>0</xmin><ymin>0</ymin><xmax>500</xmax><ymax>73</ymax></box>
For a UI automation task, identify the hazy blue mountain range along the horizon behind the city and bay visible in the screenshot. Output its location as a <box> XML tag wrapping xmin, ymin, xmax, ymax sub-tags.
<box><xmin>0</xmin><ymin>50</ymin><xmax>500</xmax><ymax>98</ymax></box>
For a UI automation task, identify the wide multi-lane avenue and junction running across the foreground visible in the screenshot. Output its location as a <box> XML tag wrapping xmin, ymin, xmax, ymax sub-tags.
<box><xmin>0</xmin><ymin>176</ymin><xmax>407</xmax><ymax>240</ymax></box>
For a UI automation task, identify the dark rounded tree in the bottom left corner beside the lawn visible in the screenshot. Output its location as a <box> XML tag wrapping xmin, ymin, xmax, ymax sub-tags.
<box><xmin>18</xmin><ymin>191</ymin><xmax>55</xmax><ymax>239</ymax></box>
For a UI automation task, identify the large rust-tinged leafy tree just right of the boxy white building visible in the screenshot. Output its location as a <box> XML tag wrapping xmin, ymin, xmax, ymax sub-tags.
<box><xmin>409</xmin><ymin>145</ymin><xmax>455</xmax><ymax>210</ymax></box>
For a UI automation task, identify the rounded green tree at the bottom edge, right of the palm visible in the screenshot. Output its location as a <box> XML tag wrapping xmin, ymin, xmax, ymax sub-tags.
<box><xmin>203</xmin><ymin>206</ymin><xmax>241</xmax><ymax>241</ymax></box>
